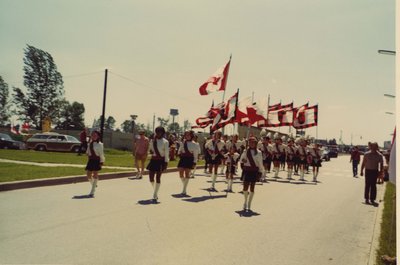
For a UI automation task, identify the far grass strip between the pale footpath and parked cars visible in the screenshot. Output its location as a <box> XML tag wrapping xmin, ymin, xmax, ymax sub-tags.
<box><xmin>0</xmin><ymin>149</ymin><xmax>204</xmax><ymax>168</ymax></box>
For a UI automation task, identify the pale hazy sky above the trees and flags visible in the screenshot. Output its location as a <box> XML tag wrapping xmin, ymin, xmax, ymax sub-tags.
<box><xmin>0</xmin><ymin>0</ymin><xmax>396</xmax><ymax>145</ymax></box>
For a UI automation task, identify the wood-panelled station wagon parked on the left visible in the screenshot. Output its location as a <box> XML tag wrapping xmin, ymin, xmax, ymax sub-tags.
<box><xmin>26</xmin><ymin>133</ymin><xmax>81</xmax><ymax>153</ymax></box>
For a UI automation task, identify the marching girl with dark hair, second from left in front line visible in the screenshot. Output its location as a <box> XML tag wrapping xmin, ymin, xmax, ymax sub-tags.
<box><xmin>146</xmin><ymin>126</ymin><xmax>170</xmax><ymax>202</ymax></box>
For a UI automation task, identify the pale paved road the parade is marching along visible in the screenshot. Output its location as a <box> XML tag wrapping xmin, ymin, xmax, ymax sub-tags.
<box><xmin>0</xmin><ymin>157</ymin><xmax>383</xmax><ymax>265</ymax></box>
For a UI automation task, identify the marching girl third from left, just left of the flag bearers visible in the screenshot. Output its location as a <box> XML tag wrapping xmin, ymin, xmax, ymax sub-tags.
<box><xmin>178</xmin><ymin>131</ymin><xmax>199</xmax><ymax>195</ymax></box>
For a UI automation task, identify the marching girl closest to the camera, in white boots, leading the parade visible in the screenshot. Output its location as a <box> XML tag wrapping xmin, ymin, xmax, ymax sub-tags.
<box><xmin>240</xmin><ymin>137</ymin><xmax>264</xmax><ymax>211</ymax></box>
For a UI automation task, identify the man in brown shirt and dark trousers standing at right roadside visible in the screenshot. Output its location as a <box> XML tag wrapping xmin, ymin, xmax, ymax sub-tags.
<box><xmin>361</xmin><ymin>142</ymin><xmax>383</xmax><ymax>206</ymax></box>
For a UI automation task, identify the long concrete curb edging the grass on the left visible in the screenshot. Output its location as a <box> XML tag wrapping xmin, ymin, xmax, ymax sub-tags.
<box><xmin>0</xmin><ymin>166</ymin><xmax>204</xmax><ymax>192</ymax></box>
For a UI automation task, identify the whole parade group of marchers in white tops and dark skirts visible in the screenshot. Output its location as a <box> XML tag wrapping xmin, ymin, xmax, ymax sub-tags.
<box><xmin>86</xmin><ymin>127</ymin><xmax>322</xmax><ymax>212</ymax></box>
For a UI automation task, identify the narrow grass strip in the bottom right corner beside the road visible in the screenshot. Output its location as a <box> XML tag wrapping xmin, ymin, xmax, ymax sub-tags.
<box><xmin>376</xmin><ymin>182</ymin><xmax>396</xmax><ymax>265</ymax></box>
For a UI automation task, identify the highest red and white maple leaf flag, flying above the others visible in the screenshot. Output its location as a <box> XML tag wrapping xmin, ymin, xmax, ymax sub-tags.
<box><xmin>199</xmin><ymin>59</ymin><xmax>231</xmax><ymax>96</ymax></box>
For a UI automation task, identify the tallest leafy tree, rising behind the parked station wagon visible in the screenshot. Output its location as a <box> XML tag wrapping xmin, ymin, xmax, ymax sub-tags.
<box><xmin>13</xmin><ymin>45</ymin><xmax>64</xmax><ymax>130</ymax></box>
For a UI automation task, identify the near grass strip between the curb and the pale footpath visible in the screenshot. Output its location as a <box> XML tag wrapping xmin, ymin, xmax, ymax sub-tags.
<box><xmin>0</xmin><ymin>163</ymin><xmax>131</xmax><ymax>182</ymax></box>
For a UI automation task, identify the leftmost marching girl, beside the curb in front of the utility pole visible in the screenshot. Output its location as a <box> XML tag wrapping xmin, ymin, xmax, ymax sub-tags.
<box><xmin>85</xmin><ymin>131</ymin><xmax>105</xmax><ymax>198</ymax></box>
